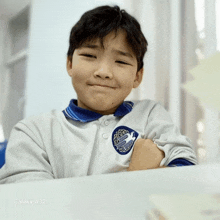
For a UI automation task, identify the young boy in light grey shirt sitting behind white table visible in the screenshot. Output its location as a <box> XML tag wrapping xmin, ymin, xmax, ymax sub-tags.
<box><xmin>0</xmin><ymin>6</ymin><xmax>196</xmax><ymax>183</ymax></box>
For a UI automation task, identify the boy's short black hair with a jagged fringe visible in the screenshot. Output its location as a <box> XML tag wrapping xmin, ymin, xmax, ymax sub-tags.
<box><xmin>67</xmin><ymin>5</ymin><xmax>148</xmax><ymax>71</ymax></box>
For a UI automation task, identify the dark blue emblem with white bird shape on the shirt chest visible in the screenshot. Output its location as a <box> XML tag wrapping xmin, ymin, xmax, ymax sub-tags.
<box><xmin>112</xmin><ymin>126</ymin><xmax>138</xmax><ymax>155</ymax></box>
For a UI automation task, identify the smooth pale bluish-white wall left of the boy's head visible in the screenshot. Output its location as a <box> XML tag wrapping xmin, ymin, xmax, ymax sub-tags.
<box><xmin>25</xmin><ymin>0</ymin><xmax>131</xmax><ymax>117</ymax></box>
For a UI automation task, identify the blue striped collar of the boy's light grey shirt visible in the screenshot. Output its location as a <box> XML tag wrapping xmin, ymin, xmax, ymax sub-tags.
<box><xmin>63</xmin><ymin>99</ymin><xmax>134</xmax><ymax>122</ymax></box>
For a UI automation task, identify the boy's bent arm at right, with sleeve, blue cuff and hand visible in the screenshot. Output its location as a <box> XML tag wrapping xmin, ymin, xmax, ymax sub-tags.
<box><xmin>128</xmin><ymin>100</ymin><xmax>197</xmax><ymax>170</ymax></box>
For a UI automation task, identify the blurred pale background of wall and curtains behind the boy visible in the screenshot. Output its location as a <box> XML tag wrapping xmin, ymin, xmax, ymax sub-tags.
<box><xmin>0</xmin><ymin>0</ymin><xmax>220</xmax><ymax>164</ymax></box>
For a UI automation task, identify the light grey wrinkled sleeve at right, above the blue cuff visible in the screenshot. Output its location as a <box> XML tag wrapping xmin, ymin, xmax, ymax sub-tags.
<box><xmin>145</xmin><ymin>103</ymin><xmax>197</xmax><ymax>166</ymax></box>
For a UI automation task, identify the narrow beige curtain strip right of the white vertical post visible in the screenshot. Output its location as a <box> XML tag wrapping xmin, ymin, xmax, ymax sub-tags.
<box><xmin>182</xmin><ymin>0</ymin><xmax>203</xmax><ymax>159</ymax></box>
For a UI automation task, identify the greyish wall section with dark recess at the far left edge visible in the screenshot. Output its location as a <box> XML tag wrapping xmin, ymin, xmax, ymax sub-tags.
<box><xmin>0</xmin><ymin>0</ymin><xmax>31</xmax><ymax>139</ymax></box>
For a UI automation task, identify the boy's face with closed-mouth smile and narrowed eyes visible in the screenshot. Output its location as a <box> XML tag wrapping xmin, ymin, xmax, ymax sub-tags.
<box><xmin>67</xmin><ymin>30</ymin><xmax>143</xmax><ymax>115</ymax></box>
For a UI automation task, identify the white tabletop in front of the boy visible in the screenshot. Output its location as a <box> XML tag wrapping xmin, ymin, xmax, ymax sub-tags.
<box><xmin>0</xmin><ymin>164</ymin><xmax>220</xmax><ymax>220</ymax></box>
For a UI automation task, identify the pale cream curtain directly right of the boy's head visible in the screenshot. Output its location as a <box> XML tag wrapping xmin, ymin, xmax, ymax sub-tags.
<box><xmin>129</xmin><ymin>0</ymin><xmax>170</xmax><ymax>109</ymax></box>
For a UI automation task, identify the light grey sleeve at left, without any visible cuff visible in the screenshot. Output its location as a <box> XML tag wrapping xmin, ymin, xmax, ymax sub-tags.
<box><xmin>0</xmin><ymin>122</ymin><xmax>54</xmax><ymax>184</ymax></box>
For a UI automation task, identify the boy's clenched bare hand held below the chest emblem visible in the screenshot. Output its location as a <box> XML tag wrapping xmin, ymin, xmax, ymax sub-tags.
<box><xmin>127</xmin><ymin>139</ymin><xmax>165</xmax><ymax>171</ymax></box>
